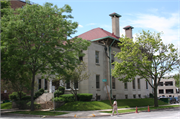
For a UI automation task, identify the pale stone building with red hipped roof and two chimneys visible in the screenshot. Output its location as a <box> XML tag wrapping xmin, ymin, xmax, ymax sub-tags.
<box><xmin>4</xmin><ymin>0</ymin><xmax>152</xmax><ymax>100</ymax></box>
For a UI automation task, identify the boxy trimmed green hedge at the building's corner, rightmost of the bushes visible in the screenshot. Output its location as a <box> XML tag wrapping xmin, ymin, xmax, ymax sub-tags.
<box><xmin>77</xmin><ymin>93</ymin><xmax>93</xmax><ymax>101</ymax></box>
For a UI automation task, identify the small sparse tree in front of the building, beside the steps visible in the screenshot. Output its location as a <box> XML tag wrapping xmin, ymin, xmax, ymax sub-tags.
<box><xmin>55</xmin><ymin>62</ymin><xmax>90</xmax><ymax>101</ymax></box>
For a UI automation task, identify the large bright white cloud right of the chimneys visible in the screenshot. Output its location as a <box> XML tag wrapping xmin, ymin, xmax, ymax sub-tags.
<box><xmin>131</xmin><ymin>13</ymin><xmax>180</xmax><ymax>47</ymax></box>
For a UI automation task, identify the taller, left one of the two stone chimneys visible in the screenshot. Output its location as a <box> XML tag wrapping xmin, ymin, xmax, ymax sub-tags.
<box><xmin>109</xmin><ymin>12</ymin><xmax>121</xmax><ymax>37</ymax></box>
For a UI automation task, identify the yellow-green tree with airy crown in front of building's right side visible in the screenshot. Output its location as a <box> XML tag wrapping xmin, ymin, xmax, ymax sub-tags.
<box><xmin>112</xmin><ymin>31</ymin><xmax>180</xmax><ymax>107</ymax></box>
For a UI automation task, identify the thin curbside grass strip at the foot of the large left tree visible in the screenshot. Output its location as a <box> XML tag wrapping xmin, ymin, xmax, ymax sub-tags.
<box><xmin>9</xmin><ymin>111</ymin><xmax>68</xmax><ymax>116</ymax></box>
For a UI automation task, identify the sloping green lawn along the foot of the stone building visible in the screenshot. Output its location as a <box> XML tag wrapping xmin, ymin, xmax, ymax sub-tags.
<box><xmin>56</xmin><ymin>98</ymin><xmax>167</xmax><ymax>111</ymax></box>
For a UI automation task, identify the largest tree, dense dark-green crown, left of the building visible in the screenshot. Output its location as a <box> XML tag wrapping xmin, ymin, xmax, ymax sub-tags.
<box><xmin>1</xmin><ymin>3</ymin><xmax>90</xmax><ymax>111</ymax></box>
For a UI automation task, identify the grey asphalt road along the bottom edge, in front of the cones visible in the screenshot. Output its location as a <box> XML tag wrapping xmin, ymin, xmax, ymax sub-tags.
<box><xmin>0</xmin><ymin>108</ymin><xmax>180</xmax><ymax>119</ymax></box>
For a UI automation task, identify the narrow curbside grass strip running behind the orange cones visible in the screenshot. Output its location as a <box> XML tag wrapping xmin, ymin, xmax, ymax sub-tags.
<box><xmin>101</xmin><ymin>105</ymin><xmax>179</xmax><ymax>113</ymax></box>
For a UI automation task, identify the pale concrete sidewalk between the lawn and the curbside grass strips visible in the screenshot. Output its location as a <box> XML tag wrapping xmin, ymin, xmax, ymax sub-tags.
<box><xmin>1</xmin><ymin>104</ymin><xmax>180</xmax><ymax>118</ymax></box>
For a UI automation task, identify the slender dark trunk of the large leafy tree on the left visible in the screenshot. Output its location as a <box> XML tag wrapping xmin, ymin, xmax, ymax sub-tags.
<box><xmin>31</xmin><ymin>72</ymin><xmax>35</xmax><ymax>111</ymax></box>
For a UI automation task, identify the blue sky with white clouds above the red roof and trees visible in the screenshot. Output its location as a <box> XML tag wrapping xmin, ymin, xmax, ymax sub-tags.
<box><xmin>31</xmin><ymin>0</ymin><xmax>180</xmax><ymax>75</ymax></box>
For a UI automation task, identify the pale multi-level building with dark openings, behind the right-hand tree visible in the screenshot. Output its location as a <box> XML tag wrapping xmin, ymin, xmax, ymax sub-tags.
<box><xmin>157</xmin><ymin>78</ymin><xmax>180</xmax><ymax>97</ymax></box>
